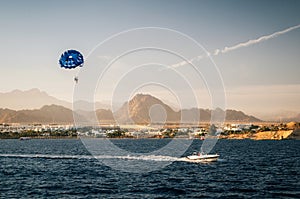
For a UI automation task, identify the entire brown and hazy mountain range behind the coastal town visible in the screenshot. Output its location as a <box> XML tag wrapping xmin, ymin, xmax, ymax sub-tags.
<box><xmin>0</xmin><ymin>89</ymin><xmax>261</xmax><ymax>124</ymax></box>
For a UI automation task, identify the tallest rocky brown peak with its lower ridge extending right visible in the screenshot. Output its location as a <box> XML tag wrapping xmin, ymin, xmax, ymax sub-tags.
<box><xmin>114</xmin><ymin>94</ymin><xmax>261</xmax><ymax>124</ymax></box>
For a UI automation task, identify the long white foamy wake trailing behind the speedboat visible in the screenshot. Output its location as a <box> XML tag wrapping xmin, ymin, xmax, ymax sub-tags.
<box><xmin>0</xmin><ymin>154</ymin><xmax>220</xmax><ymax>162</ymax></box>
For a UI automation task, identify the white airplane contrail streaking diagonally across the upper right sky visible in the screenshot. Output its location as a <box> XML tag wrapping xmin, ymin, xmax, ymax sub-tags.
<box><xmin>171</xmin><ymin>24</ymin><xmax>300</xmax><ymax>67</ymax></box>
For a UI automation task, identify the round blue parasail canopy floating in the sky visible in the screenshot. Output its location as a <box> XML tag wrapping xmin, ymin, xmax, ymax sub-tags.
<box><xmin>59</xmin><ymin>50</ymin><xmax>84</xmax><ymax>69</ymax></box>
